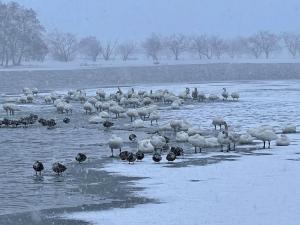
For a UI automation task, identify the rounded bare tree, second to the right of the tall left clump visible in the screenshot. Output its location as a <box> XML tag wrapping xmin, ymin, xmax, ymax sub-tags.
<box><xmin>78</xmin><ymin>36</ymin><xmax>102</xmax><ymax>62</ymax></box>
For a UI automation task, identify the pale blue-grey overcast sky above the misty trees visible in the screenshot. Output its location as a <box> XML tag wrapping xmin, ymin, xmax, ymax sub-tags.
<box><xmin>5</xmin><ymin>0</ymin><xmax>300</xmax><ymax>39</ymax></box>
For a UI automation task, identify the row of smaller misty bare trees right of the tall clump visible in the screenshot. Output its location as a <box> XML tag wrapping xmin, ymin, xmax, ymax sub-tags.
<box><xmin>48</xmin><ymin>31</ymin><xmax>300</xmax><ymax>62</ymax></box>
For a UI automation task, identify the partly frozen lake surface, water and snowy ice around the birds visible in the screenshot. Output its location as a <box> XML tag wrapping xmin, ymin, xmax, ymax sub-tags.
<box><xmin>0</xmin><ymin>80</ymin><xmax>300</xmax><ymax>224</ymax></box>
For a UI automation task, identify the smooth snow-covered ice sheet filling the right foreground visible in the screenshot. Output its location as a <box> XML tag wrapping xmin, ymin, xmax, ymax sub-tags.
<box><xmin>65</xmin><ymin>134</ymin><xmax>300</xmax><ymax>225</ymax></box>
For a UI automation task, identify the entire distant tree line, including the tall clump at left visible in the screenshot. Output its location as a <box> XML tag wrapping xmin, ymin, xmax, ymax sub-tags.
<box><xmin>0</xmin><ymin>2</ymin><xmax>300</xmax><ymax>66</ymax></box>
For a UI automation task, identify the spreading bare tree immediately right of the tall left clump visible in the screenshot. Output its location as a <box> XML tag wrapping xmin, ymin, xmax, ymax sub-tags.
<box><xmin>48</xmin><ymin>31</ymin><xmax>78</xmax><ymax>62</ymax></box>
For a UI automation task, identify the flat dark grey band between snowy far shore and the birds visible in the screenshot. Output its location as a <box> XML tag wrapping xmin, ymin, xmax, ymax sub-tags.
<box><xmin>0</xmin><ymin>63</ymin><xmax>300</xmax><ymax>93</ymax></box>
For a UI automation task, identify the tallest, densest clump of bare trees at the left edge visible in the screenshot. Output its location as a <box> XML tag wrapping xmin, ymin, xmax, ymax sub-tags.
<box><xmin>0</xmin><ymin>2</ymin><xmax>47</xmax><ymax>66</ymax></box>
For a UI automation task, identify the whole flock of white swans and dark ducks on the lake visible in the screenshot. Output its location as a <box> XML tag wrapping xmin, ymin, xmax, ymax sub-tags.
<box><xmin>0</xmin><ymin>84</ymin><xmax>296</xmax><ymax>174</ymax></box>
